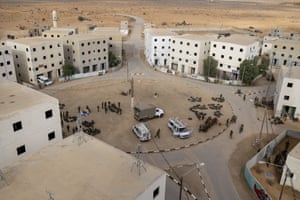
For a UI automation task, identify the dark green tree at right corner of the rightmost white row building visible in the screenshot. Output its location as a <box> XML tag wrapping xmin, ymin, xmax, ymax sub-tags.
<box><xmin>239</xmin><ymin>60</ymin><xmax>259</xmax><ymax>85</ymax></box>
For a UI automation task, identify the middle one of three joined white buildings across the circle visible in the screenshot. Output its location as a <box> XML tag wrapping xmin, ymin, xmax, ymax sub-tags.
<box><xmin>169</xmin><ymin>34</ymin><xmax>217</xmax><ymax>74</ymax></box>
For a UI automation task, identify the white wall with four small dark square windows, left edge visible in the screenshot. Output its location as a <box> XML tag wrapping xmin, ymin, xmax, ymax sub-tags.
<box><xmin>0</xmin><ymin>101</ymin><xmax>62</xmax><ymax>168</ymax></box>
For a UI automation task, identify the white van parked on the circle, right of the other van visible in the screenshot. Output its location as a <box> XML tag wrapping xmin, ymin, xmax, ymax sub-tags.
<box><xmin>168</xmin><ymin>117</ymin><xmax>192</xmax><ymax>139</ymax></box>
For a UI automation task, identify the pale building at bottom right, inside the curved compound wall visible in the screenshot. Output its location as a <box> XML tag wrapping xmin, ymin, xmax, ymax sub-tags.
<box><xmin>280</xmin><ymin>143</ymin><xmax>300</xmax><ymax>192</ymax></box>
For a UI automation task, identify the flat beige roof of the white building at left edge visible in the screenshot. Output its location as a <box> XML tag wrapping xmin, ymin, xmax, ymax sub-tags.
<box><xmin>0</xmin><ymin>80</ymin><xmax>58</xmax><ymax>119</ymax></box>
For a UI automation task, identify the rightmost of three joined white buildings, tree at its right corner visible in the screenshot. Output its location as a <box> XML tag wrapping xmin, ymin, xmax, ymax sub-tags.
<box><xmin>210</xmin><ymin>34</ymin><xmax>260</xmax><ymax>79</ymax></box>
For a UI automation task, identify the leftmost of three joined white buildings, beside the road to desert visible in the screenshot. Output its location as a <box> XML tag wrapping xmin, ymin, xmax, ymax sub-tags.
<box><xmin>144</xmin><ymin>29</ymin><xmax>177</xmax><ymax>66</ymax></box>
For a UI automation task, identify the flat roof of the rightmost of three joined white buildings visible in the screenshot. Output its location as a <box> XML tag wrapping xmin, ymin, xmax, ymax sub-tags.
<box><xmin>214</xmin><ymin>34</ymin><xmax>259</xmax><ymax>45</ymax></box>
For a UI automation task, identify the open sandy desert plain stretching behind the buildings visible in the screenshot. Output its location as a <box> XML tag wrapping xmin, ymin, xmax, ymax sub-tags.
<box><xmin>0</xmin><ymin>0</ymin><xmax>300</xmax><ymax>39</ymax></box>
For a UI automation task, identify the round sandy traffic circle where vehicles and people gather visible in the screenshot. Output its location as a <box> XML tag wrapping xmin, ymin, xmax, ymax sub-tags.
<box><xmin>54</xmin><ymin>77</ymin><xmax>233</xmax><ymax>151</ymax></box>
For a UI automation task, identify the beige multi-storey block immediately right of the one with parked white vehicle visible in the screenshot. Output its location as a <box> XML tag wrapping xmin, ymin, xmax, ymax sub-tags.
<box><xmin>63</xmin><ymin>34</ymin><xmax>109</xmax><ymax>73</ymax></box>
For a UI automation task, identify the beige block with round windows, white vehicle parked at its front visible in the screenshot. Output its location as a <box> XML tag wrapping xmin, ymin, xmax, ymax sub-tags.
<box><xmin>6</xmin><ymin>37</ymin><xmax>64</xmax><ymax>85</ymax></box>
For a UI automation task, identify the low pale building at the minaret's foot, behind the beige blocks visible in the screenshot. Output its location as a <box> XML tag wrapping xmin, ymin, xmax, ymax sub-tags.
<box><xmin>42</xmin><ymin>27</ymin><xmax>78</xmax><ymax>39</ymax></box>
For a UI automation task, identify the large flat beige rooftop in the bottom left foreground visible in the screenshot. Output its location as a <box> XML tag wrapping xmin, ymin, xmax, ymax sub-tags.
<box><xmin>0</xmin><ymin>133</ymin><xmax>165</xmax><ymax>200</ymax></box>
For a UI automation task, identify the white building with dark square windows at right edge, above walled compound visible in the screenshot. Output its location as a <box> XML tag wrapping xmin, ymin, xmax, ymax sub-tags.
<box><xmin>274</xmin><ymin>66</ymin><xmax>300</xmax><ymax>119</ymax></box>
